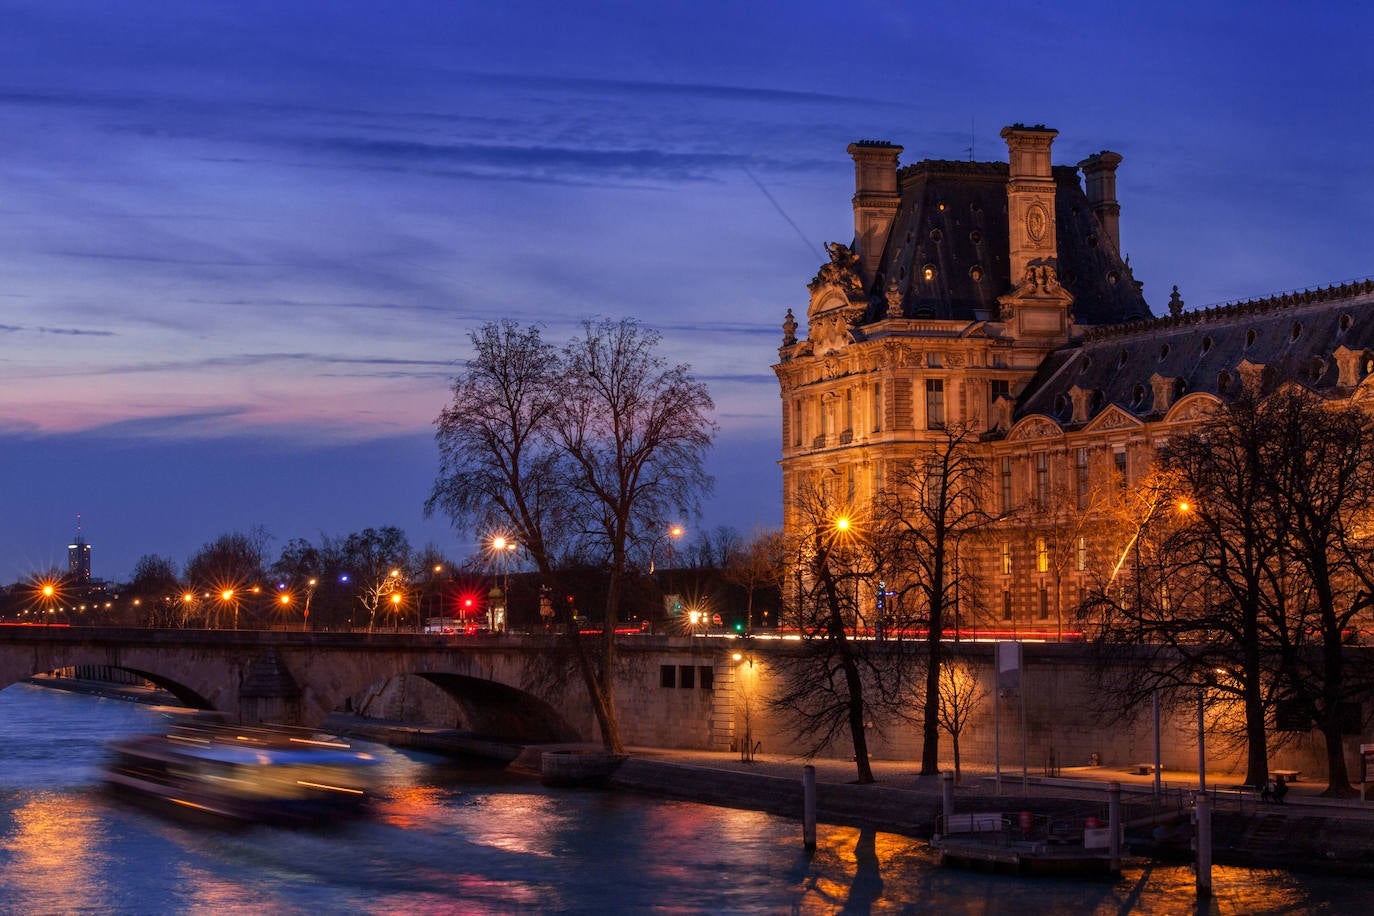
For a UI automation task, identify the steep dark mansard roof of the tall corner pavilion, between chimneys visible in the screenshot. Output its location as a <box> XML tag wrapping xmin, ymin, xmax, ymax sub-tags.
<box><xmin>864</xmin><ymin>159</ymin><xmax>1150</xmax><ymax>325</ymax></box>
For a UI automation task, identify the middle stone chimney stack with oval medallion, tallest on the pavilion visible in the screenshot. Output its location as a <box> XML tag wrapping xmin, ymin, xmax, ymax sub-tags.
<box><xmin>1002</xmin><ymin>124</ymin><xmax>1059</xmax><ymax>286</ymax></box>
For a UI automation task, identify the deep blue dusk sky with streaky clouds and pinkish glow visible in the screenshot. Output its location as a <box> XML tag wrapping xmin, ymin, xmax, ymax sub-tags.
<box><xmin>0</xmin><ymin>0</ymin><xmax>1374</xmax><ymax>582</ymax></box>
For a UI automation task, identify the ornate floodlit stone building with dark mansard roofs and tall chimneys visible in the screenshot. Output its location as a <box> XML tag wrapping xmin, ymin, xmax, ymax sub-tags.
<box><xmin>774</xmin><ymin>125</ymin><xmax>1374</xmax><ymax>637</ymax></box>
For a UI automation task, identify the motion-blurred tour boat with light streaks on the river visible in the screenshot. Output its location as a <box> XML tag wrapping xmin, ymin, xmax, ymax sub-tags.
<box><xmin>104</xmin><ymin>724</ymin><xmax>379</xmax><ymax>827</ymax></box>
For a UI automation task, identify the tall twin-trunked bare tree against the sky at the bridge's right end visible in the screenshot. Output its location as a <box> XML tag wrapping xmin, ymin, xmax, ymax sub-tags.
<box><xmin>426</xmin><ymin>315</ymin><xmax>714</xmax><ymax>751</ymax></box>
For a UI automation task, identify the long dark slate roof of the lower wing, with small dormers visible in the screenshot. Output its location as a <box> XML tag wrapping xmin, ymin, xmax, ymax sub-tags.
<box><xmin>1015</xmin><ymin>280</ymin><xmax>1374</xmax><ymax>426</ymax></box>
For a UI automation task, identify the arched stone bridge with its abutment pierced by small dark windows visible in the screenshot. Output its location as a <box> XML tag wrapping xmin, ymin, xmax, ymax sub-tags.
<box><xmin>0</xmin><ymin>626</ymin><xmax>734</xmax><ymax>747</ymax></box>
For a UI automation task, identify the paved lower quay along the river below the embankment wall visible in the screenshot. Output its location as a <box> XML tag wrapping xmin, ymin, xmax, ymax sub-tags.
<box><xmin>611</xmin><ymin>748</ymin><xmax>1374</xmax><ymax>878</ymax></box>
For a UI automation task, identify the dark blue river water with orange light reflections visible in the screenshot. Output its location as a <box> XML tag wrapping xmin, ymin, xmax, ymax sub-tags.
<box><xmin>0</xmin><ymin>685</ymin><xmax>1374</xmax><ymax>916</ymax></box>
